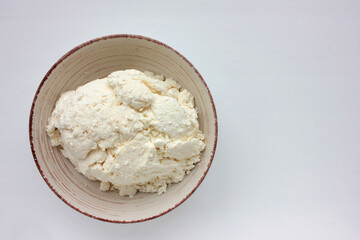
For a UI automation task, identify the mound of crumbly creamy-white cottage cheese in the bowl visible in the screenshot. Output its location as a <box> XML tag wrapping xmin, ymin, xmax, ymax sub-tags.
<box><xmin>46</xmin><ymin>69</ymin><xmax>205</xmax><ymax>197</ymax></box>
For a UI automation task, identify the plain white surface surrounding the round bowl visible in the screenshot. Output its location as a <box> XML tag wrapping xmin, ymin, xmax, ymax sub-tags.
<box><xmin>0</xmin><ymin>0</ymin><xmax>360</xmax><ymax>240</ymax></box>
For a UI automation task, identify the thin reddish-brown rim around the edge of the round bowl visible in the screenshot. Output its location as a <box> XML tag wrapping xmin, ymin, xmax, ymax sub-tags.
<box><xmin>29</xmin><ymin>34</ymin><xmax>218</xmax><ymax>223</ymax></box>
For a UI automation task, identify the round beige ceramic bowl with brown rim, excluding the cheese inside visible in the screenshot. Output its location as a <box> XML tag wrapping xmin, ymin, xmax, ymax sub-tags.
<box><xmin>29</xmin><ymin>35</ymin><xmax>217</xmax><ymax>223</ymax></box>
